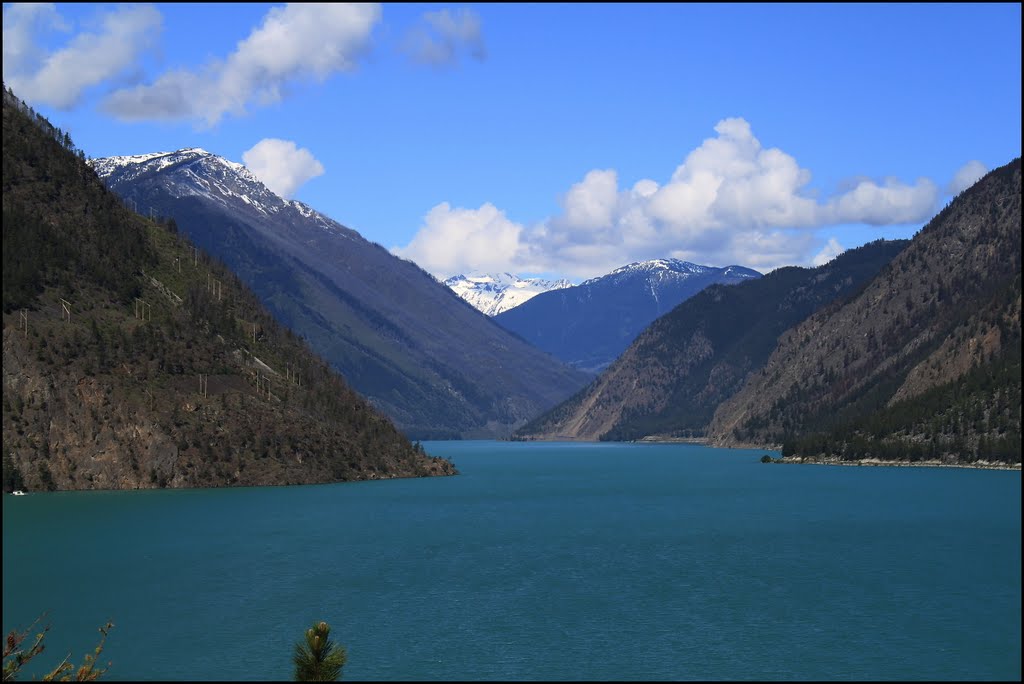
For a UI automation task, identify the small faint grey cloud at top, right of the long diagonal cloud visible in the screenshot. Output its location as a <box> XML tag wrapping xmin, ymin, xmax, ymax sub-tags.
<box><xmin>404</xmin><ymin>8</ymin><xmax>487</xmax><ymax>67</ymax></box>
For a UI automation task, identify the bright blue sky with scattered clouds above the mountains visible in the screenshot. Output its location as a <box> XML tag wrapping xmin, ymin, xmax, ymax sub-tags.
<box><xmin>3</xmin><ymin>3</ymin><xmax>1021</xmax><ymax>281</ymax></box>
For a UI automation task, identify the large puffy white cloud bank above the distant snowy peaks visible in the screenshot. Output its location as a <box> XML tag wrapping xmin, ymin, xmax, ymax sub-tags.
<box><xmin>399</xmin><ymin>119</ymin><xmax>939</xmax><ymax>277</ymax></box>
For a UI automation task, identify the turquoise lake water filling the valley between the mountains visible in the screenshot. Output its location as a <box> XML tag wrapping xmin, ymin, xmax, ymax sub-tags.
<box><xmin>3</xmin><ymin>441</ymin><xmax>1021</xmax><ymax>680</ymax></box>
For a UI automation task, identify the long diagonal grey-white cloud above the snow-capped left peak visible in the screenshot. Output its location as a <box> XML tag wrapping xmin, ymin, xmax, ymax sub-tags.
<box><xmin>103</xmin><ymin>3</ymin><xmax>381</xmax><ymax>125</ymax></box>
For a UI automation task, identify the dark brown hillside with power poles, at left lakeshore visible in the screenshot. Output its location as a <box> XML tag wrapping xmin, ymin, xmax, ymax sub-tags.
<box><xmin>2</xmin><ymin>89</ymin><xmax>455</xmax><ymax>489</ymax></box>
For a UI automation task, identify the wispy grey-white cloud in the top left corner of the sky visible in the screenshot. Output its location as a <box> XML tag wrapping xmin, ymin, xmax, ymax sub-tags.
<box><xmin>3</xmin><ymin>3</ymin><xmax>163</xmax><ymax>110</ymax></box>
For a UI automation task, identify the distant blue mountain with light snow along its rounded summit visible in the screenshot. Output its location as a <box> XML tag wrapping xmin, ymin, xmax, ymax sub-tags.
<box><xmin>495</xmin><ymin>259</ymin><xmax>761</xmax><ymax>372</ymax></box>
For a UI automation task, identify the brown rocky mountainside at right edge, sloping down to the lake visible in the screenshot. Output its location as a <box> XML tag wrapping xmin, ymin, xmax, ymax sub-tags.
<box><xmin>709</xmin><ymin>158</ymin><xmax>1021</xmax><ymax>463</ymax></box>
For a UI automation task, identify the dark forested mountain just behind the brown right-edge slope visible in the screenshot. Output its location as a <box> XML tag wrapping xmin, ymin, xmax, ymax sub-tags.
<box><xmin>516</xmin><ymin>241</ymin><xmax>908</xmax><ymax>440</ymax></box>
